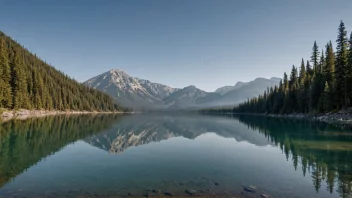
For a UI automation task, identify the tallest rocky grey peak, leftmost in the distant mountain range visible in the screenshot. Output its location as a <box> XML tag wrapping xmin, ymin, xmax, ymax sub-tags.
<box><xmin>84</xmin><ymin>69</ymin><xmax>178</xmax><ymax>109</ymax></box>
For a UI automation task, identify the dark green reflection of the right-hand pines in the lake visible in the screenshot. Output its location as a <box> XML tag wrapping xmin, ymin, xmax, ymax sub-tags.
<box><xmin>234</xmin><ymin>115</ymin><xmax>352</xmax><ymax>197</ymax></box>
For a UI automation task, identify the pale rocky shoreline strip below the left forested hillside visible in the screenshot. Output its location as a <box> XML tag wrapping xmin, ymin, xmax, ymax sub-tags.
<box><xmin>0</xmin><ymin>109</ymin><xmax>133</xmax><ymax>122</ymax></box>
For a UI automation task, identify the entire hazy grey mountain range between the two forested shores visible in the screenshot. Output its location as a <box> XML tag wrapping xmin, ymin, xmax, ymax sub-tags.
<box><xmin>84</xmin><ymin>69</ymin><xmax>280</xmax><ymax>110</ymax></box>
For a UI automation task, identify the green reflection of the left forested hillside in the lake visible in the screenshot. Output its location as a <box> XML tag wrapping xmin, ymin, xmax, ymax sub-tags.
<box><xmin>0</xmin><ymin>115</ymin><xmax>119</xmax><ymax>187</ymax></box>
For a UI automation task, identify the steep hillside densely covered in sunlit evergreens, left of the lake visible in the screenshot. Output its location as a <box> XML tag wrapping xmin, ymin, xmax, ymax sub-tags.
<box><xmin>0</xmin><ymin>32</ymin><xmax>126</xmax><ymax>111</ymax></box>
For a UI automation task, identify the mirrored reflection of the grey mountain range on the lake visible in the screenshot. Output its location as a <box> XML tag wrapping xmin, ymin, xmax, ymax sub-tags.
<box><xmin>85</xmin><ymin>114</ymin><xmax>272</xmax><ymax>153</ymax></box>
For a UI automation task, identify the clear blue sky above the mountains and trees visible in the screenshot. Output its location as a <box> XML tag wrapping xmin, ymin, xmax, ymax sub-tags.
<box><xmin>0</xmin><ymin>0</ymin><xmax>352</xmax><ymax>91</ymax></box>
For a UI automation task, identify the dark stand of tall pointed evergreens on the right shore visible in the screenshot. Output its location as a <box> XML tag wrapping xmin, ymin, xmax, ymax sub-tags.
<box><xmin>233</xmin><ymin>21</ymin><xmax>352</xmax><ymax>114</ymax></box>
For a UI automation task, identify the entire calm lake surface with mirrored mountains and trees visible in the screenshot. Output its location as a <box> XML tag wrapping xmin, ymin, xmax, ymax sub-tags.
<box><xmin>0</xmin><ymin>114</ymin><xmax>352</xmax><ymax>198</ymax></box>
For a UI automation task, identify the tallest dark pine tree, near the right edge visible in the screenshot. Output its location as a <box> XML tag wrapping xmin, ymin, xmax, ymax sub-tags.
<box><xmin>335</xmin><ymin>21</ymin><xmax>348</xmax><ymax>109</ymax></box>
